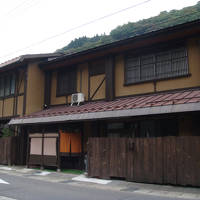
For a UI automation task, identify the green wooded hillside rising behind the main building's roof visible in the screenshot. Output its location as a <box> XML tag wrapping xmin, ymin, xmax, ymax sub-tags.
<box><xmin>56</xmin><ymin>2</ymin><xmax>200</xmax><ymax>54</ymax></box>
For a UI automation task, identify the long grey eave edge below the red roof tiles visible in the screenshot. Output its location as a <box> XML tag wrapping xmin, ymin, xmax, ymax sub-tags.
<box><xmin>9</xmin><ymin>103</ymin><xmax>200</xmax><ymax>125</ymax></box>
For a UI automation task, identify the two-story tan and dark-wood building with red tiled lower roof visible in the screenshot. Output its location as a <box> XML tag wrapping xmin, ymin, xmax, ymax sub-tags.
<box><xmin>9</xmin><ymin>20</ymin><xmax>200</xmax><ymax>186</ymax></box>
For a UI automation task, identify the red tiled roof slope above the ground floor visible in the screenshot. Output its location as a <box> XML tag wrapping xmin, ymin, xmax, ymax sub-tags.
<box><xmin>19</xmin><ymin>88</ymin><xmax>200</xmax><ymax>119</ymax></box>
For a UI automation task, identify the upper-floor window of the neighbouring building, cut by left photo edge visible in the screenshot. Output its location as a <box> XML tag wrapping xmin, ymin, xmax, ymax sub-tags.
<box><xmin>0</xmin><ymin>74</ymin><xmax>16</xmax><ymax>97</ymax></box>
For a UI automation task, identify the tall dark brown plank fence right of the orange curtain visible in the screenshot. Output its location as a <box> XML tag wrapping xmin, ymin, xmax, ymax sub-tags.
<box><xmin>88</xmin><ymin>136</ymin><xmax>200</xmax><ymax>186</ymax></box>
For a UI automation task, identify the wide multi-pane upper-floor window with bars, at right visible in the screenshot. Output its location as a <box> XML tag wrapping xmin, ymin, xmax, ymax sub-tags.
<box><xmin>125</xmin><ymin>47</ymin><xmax>189</xmax><ymax>84</ymax></box>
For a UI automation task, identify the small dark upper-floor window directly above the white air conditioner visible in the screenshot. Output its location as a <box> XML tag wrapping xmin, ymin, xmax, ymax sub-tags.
<box><xmin>57</xmin><ymin>69</ymin><xmax>77</xmax><ymax>96</ymax></box>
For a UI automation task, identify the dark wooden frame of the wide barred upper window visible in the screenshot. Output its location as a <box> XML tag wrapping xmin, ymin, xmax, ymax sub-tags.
<box><xmin>124</xmin><ymin>44</ymin><xmax>191</xmax><ymax>86</ymax></box>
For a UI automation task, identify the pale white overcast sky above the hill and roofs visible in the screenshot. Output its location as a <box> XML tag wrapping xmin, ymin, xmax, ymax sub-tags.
<box><xmin>0</xmin><ymin>0</ymin><xmax>199</xmax><ymax>63</ymax></box>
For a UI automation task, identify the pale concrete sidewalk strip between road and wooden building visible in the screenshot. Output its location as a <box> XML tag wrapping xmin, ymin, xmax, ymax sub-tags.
<box><xmin>0</xmin><ymin>165</ymin><xmax>200</xmax><ymax>199</ymax></box>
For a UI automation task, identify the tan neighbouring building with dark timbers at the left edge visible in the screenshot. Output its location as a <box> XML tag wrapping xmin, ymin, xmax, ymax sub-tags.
<box><xmin>0</xmin><ymin>54</ymin><xmax>60</xmax><ymax>162</ymax></box>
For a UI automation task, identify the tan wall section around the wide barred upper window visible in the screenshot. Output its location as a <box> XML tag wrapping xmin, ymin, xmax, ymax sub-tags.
<box><xmin>115</xmin><ymin>38</ymin><xmax>200</xmax><ymax>97</ymax></box>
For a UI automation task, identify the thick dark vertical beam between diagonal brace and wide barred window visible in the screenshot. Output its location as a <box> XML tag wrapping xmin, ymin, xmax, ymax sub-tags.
<box><xmin>105</xmin><ymin>55</ymin><xmax>115</xmax><ymax>101</ymax></box>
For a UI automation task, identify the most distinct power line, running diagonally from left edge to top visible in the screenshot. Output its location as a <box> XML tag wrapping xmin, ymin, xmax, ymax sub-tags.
<box><xmin>0</xmin><ymin>0</ymin><xmax>152</xmax><ymax>58</ymax></box>
